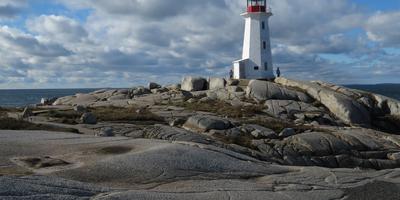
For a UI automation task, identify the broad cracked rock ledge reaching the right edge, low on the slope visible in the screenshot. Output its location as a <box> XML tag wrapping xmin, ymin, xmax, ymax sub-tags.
<box><xmin>253</xmin><ymin>129</ymin><xmax>400</xmax><ymax>169</ymax></box>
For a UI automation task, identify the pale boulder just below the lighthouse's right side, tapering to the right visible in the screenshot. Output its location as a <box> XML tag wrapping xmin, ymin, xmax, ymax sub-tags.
<box><xmin>246</xmin><ymin>80</ymin><xmax>312</xmax><ymax>102</ymax></box>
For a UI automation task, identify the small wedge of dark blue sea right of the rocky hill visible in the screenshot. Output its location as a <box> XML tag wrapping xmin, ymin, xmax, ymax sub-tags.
<box><xmin>346</xmin><ymin>84</ymin><xmax>400</xmax><ymax>100</ymax></box>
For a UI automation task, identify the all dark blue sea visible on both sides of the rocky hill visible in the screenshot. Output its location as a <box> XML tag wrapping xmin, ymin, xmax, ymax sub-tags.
<box><xmin>0</xmin><ymin>84</ymin><xmax>400</xmax><ymax>107</ymax></box>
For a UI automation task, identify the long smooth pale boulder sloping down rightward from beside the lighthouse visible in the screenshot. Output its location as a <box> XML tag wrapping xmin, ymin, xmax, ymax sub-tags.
<box><xmin>275</xmin><ymin>77</ymin><xmax>371</xmax><ymax>126</ymax></box>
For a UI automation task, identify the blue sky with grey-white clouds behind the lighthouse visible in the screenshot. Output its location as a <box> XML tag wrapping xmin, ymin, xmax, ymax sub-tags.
<box><xmin>0</xmin><ymin>0</ymin><xmax>400</xmax><ymax>89</ymax></box>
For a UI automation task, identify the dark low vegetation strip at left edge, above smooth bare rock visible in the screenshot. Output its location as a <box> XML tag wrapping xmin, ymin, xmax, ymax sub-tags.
<box><xmin>0</xmin><ymin>117</ymin><xmax>79</xmax><ymax>133</ymax></box>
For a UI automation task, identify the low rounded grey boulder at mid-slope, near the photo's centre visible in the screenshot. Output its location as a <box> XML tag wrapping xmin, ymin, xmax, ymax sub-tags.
<box><xmin>184</xmin><ymin>115</ymin><xmax>232</xmax><ymax>131</ymax></box>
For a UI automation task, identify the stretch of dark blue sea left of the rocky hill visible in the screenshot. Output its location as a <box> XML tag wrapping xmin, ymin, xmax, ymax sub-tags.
<box><xmin>0</xmin><ymin>89</ymin><xmax>98</xmax><ymax>107</ymax></box>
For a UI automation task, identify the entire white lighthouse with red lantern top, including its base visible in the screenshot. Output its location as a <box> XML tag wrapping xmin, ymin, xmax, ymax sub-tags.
<box><xmin>233</xmin><ymin>0</ymin><xmax>275</xmax><ymax>79</ymax></box>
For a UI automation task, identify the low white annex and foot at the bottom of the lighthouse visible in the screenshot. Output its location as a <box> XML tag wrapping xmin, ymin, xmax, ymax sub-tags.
<box><xmin>233</xmin><ymin>59</ymin><xmax>275</xmax><ymax>80</ymax></box>
